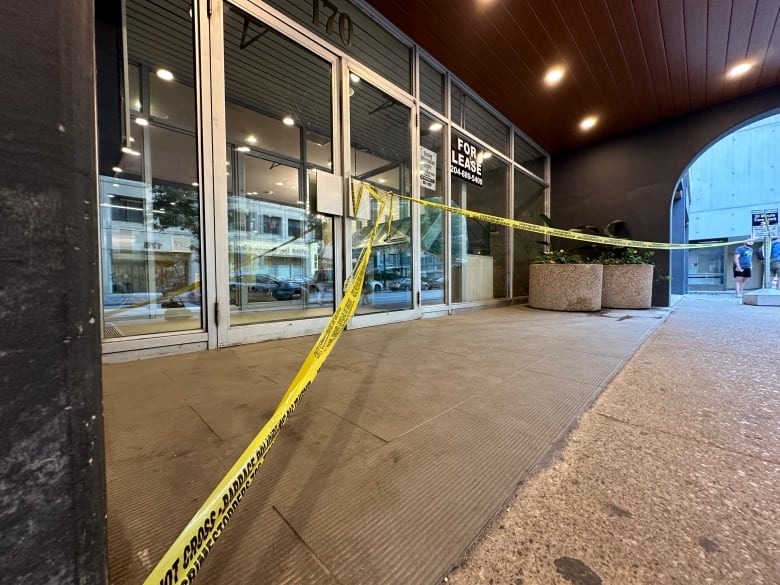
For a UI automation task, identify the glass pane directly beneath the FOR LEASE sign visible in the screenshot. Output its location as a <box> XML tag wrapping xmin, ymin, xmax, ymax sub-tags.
<box><xmin>451</xmin><ymin>133</ymin><xmax>510</xmax><ymax>302</ymax></box>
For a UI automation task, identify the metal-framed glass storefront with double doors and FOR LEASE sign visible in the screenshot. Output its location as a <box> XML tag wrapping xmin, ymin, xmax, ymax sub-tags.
<box><xmin>96</xmin><ymin>0</ymin><xmax>549</xmax><ymax>360</ymax></box>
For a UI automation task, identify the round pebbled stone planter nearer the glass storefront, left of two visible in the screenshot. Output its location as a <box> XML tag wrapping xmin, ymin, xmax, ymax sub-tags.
<box><xmin>528</xmin><ymin>264</ymin><xmax>604</xmax><ymax>311</ymax></box>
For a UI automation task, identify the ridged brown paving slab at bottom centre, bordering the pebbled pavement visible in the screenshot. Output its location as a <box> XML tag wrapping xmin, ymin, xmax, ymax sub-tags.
<box><xmin>277</xmin><ymin>411</ymin><xmax>547</xmax><ymax>585</ymax></box>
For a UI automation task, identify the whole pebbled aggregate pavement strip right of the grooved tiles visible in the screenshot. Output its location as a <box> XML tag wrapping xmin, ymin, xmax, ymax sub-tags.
<box><xmin>447</xmin><ymin>296</ymin><xmax>780</xmax><ymax>585</ymax></box>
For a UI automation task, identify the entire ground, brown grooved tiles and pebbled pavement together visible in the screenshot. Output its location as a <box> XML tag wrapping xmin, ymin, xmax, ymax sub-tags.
<box><xmin>104</xmin><ymin>297</ymin><xmax>780</xmax><ymax>585</ymax></box>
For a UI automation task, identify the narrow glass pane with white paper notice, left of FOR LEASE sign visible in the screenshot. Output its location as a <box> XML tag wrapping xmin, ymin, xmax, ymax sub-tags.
<box><xmin>420</xmin><ymin>114</ymin><xmax>447</xmax><ymax>305</ymax></box>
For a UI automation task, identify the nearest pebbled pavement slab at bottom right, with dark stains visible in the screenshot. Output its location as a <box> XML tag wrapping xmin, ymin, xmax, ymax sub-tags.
<box><xmin>448</xmin><ymin>402</ymin><xmax>780</xmax><ymax>585</ymax></box>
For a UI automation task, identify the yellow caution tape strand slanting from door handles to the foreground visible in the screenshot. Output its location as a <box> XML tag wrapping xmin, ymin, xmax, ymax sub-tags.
<box><xmin>144</xmin><ymin>196</ymin><xmax>385</xmax><ymax>585</ymax></box>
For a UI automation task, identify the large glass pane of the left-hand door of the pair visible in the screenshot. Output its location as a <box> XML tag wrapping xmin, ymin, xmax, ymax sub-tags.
<box><xmin>222</xmin><ymin>5</ymin><xmax>334</xmax><ymax>327</ymax></box>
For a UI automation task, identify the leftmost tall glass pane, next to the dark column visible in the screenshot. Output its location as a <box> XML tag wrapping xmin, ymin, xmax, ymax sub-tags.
<box><xmin>98</xmin><ymin>0</ymin><xmax>203</xmax><ymax>338</ymax></box>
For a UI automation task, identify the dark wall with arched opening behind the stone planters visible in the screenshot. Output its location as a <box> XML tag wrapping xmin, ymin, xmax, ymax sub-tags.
<box><xmin>551</xmin><ymin>86</ymin><xmax>780</xmax><ymax>306</ymax></box>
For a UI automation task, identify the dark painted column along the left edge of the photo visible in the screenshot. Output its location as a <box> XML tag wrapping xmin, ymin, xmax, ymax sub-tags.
<box><xmin>0</xmin><ymin>0</ymin><xmax>107</xmax><ymax>585</ymax></box>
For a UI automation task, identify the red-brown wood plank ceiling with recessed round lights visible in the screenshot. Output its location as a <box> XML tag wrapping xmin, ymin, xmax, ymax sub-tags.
<box><xmin>362</xmin><ymin>0</ymin><xmax>780</xmax><ymax>153</ymax></box>
